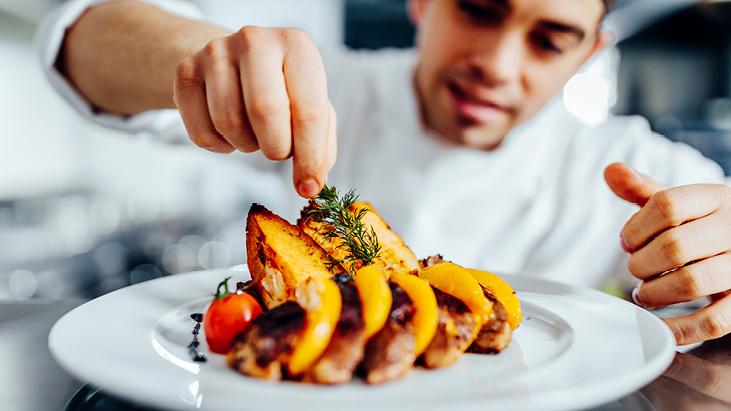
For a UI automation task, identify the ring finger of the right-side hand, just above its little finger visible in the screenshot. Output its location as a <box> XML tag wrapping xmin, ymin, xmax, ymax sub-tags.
<box><xmin>635</xmin><ymin>253</ymin><xmax>731</xmax><ymax>308</ymax></box>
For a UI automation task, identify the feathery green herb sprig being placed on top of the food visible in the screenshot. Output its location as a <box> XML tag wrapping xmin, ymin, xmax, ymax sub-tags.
<box><xmin>305</xmin><ymin>185</ymin><xmax>381</xmax><ymax>274</ymax></box>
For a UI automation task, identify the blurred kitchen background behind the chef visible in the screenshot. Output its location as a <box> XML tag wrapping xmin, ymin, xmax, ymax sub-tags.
<box><xmin>0</xmin><ymin>0</ymin><xmax>731</xmax><ymax>299</ymax></box>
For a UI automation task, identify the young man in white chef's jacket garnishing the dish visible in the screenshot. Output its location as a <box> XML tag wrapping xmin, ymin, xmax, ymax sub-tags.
<box><xmin>40</xmin><ymin>0</ymin><xmax>731</xmax><ymax>344</ymax></box>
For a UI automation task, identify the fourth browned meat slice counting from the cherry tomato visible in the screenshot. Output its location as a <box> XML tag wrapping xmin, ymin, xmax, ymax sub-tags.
<box><xmin>421</xmin><ymin>288</ymin><xmax>475</xmax><ymax>368</ymax></box>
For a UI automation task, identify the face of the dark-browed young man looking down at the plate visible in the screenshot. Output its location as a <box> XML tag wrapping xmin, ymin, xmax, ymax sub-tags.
<box><xmin>410</xmin><ymin>0</ymin><xmax>605</xmax><ymax>149</ymax></box>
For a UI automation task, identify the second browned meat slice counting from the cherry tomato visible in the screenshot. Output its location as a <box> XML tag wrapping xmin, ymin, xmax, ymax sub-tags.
<box><xmin>304</xmin><ymin>274</ymin><xmax>366</xmax><ymax>384</ymax></box>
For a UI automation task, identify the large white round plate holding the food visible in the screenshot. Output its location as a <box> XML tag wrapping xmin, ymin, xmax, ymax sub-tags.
<box><xmin>49</xmin><ymin>266</ymin><xmax>675</xmax><ymax>411</ymax></box>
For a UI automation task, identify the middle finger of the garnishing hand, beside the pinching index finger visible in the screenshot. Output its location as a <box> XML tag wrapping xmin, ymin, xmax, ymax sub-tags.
<box><xmin>239</xmin><ymin>27</ymin><xmax>292</xmax><ymax>160</ymax></box>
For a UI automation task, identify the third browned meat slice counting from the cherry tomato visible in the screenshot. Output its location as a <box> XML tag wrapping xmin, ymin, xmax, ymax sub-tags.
<box><xmin>363</xmin><ymin>283</ymin><xmax>415</xmax><ymax>384</ymax></box>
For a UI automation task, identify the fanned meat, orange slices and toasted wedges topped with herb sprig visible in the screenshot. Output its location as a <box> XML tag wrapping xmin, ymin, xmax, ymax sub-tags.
<box><xmin>206</xmin><ymin>187</ymin><xmax>521</xmax><ymax>384</ymax></box>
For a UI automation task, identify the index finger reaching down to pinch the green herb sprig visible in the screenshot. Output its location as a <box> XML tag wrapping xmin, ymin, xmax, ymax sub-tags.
<box><xmin>282</xmin><ymin>30</ymin><xmax>331</xmax><ymax>198</ymax></box>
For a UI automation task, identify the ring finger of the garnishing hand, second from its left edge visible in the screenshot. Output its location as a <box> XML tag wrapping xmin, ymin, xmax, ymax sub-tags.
<box><xmin>202</xmin><ymin>40</ymin><xmax>259</xmax><ymax>153</ymax></box>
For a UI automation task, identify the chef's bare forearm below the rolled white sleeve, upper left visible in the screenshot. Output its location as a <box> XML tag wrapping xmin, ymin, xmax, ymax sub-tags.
<box><xmin>60</xmin><ymin>1</ymin><xmax>230</xmax><ymax>115</ymax></box>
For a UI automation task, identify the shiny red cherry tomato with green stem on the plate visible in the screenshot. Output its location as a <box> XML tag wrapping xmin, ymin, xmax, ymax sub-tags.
<box><xmin>203</xmin><ymin>278</ymin><xmax>262</xmax><ymax>354</ymax></box>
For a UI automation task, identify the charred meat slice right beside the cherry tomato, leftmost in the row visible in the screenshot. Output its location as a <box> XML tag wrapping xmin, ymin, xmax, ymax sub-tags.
<box><xmin>227</xmin><ymin>301</ymin><xmax>306</xmax><ymax>380</ymax></box>
